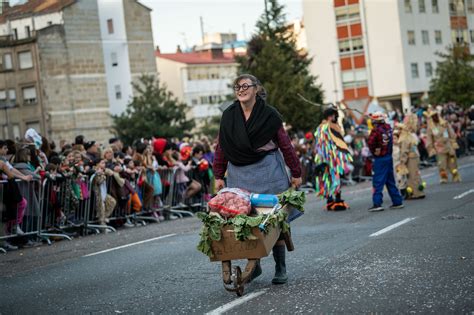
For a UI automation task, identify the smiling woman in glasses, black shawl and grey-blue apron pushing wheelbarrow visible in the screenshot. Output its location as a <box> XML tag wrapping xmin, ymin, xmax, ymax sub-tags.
<box><xmin>213</xmin><ymin>74</ymin><xmax>301</xmax><ymax>284</ymax></box>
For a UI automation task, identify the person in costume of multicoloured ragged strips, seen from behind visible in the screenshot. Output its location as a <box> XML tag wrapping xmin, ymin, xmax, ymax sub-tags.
<box><xmin>314</xmin><ymin>106</ymin><xmax>352</xmax><ymax>211</ymax></box>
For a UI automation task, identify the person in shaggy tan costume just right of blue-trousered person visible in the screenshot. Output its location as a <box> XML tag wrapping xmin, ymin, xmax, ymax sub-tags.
<box><xmin>395</xmin><ymin>114</ymin><xmax>425</xmax><ymax>199</ymax></box>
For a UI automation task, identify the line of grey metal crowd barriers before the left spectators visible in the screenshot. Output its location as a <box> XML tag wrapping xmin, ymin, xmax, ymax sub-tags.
<box><xmin>0</xmin><ymin>165</ymin><xmax>204</xmax><ymax>252</ymax></box>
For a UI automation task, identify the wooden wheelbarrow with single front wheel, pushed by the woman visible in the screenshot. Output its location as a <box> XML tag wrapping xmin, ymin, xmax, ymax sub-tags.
<box><xmin>211</xmin><ymin>220</ymin><xmax>294</xmax><ymax>296</ymax></box>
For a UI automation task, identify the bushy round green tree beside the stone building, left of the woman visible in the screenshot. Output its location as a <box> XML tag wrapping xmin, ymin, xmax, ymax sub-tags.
<box><xmin>113</xmin><ymin>75</ymin><xmax>194</xmax><ymax>143</ymax></box>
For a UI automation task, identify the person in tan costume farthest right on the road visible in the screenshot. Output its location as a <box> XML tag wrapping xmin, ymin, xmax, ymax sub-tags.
<box><xmin>426</xmin><ymin>110</ymin><xmax>461</xmax><ymax>184</ymax></box>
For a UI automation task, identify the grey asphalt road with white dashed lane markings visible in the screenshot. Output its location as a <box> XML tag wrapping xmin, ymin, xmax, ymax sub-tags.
<box><xmin>0</xmin><ymin>157</ymin><xmax>474</xmax><ymax>314</ymax></box>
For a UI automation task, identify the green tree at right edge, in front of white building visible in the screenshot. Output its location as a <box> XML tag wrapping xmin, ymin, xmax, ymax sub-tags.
<box><xmin>429</xmin><ymin>45</ymin><xmax>474</xmax><ymax>108</ymax></box>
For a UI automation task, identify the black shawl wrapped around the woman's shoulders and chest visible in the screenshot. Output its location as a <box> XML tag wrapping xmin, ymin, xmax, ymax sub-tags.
<box><xmin>219</xmin><ymin>96</ymin><xmax>283</xmax><ymax>166</ymax></box>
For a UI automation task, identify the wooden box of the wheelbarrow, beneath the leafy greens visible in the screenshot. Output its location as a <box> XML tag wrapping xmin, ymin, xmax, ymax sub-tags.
<box><xmin>211</xmin><ymin>225</ymin><xmax>280</xmax><ymax>261</ymax></box>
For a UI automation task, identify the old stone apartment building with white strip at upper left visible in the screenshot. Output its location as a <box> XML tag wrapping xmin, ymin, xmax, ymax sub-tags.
<box><xmin>0</xmin><ymin>0</ymin><xmax>156</xmax><ymax>142</ymax></box>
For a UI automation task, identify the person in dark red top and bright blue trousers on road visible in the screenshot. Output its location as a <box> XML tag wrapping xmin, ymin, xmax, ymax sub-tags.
<box><xmin>368</xmin><ymin>112</ymin><xmax>403</xmax><ymax>212</ymax></box>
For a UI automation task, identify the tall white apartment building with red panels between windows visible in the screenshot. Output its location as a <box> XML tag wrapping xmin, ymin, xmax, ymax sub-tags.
<box><xmin>303</xmin><ymin>0</ymin><xmax>474</xmax><ymax>120</ymax></box>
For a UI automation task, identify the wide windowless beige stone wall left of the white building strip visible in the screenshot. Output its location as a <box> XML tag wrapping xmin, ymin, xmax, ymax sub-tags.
<box><xmin>38</xmin><ymin>0</ymin><xmax>111</xmax><ymax>142</ymax></box>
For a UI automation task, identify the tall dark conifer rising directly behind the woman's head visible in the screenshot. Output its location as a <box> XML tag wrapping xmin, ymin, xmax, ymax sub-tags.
<box><xmin>237</xmin><ymin>0</ymin><xmax>323</xmax><ymax>130</ymax></box>
